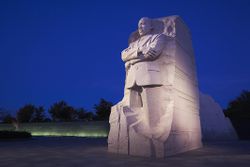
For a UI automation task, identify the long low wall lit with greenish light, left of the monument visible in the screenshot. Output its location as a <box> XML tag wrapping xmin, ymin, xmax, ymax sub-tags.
<box><xmin>0</xmin><ymin>121</ymin><xmax>109</xmax><ymax>137</ymax></box>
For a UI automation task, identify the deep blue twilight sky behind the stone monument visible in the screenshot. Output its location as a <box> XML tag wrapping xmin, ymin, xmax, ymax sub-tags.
<box><xmin>0</xmin><ymin>0</ymin><xmax>250</xmax><ymax>112</ymax></box>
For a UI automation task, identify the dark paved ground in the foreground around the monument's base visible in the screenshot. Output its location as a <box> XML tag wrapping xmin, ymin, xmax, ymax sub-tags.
<box><xmin>0</xmin><ymin>137</ymin><xmax>250</xmax><ymax>167</ymax></box>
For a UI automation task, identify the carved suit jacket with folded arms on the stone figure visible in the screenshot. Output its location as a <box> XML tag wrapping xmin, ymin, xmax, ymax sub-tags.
<box><xmin>122</xmin><ymin>34</ymin><xmax>166</xmax><ymax>88</ymax></box>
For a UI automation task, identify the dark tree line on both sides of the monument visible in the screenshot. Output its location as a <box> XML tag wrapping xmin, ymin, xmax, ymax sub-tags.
<box><xmin>0</xmin><ymin>90</ymin><xmax>250</xmax><ymax>139</ymax></box>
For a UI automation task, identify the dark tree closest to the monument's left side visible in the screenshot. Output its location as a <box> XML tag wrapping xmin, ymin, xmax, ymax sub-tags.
<box><xmin>94</xmin><ymin>98</ymin><xmax>113</xmax><ymax>120</ymax></box>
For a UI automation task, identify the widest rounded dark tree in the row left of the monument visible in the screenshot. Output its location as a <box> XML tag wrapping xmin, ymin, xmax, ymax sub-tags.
<box><xmin>49</xmin><ymin>100</ymin><xmax>76</xmax><ymax>121</ymax></box>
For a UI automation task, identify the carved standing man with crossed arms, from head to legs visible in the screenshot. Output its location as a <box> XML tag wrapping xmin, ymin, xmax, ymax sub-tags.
<box><xmin>122</xmin><ymin>18</ymin><xmax>167</xmax><ymax>138</ymax></box>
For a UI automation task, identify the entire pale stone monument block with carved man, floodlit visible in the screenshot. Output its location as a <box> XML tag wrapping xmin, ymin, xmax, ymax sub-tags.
<box><xmin>108</xmin><ymin>16</ymin><xmax>202</xmax><ymax>157</ymax></box>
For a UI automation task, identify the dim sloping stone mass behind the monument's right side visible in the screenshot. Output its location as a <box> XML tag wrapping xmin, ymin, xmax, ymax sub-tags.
<box><xmin>200</xmin><ymin>92</ymin><xmax>238</xmax><ymax>141</ymax></box>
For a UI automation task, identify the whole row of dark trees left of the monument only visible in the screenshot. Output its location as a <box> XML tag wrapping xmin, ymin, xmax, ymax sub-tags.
<box><xmin>0</xmin><ymin>98</ymin><xmax>113</xmax><ymax>123</ymax></box>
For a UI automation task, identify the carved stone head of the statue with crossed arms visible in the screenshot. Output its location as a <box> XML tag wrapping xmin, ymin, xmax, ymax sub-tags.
<box><xmin>138</xmin><ymin>17</ymin><xmax>153</xmax><ymax>36</ymax></box>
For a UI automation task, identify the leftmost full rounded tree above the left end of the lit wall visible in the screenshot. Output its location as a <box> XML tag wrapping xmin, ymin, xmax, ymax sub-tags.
<box><xmin>17</xmin><ymin>104</ymin><xmax>36</xmax><ymax>122</ymax></box>
